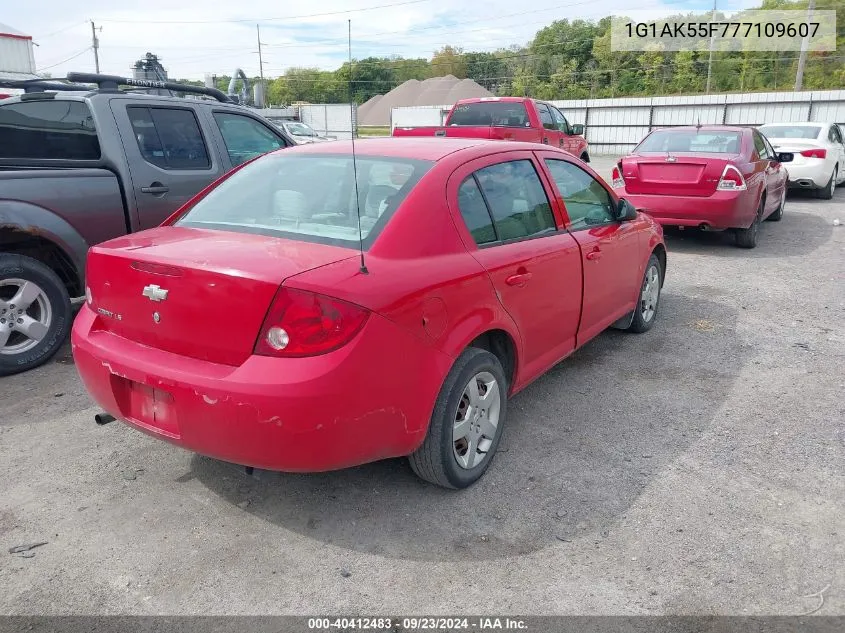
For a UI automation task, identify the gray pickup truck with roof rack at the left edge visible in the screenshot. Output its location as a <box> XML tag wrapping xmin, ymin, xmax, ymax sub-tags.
<box><xmin>0</xmin><ymin>73</ymin><xmax>295</xmax><ymax>376</ymax></box>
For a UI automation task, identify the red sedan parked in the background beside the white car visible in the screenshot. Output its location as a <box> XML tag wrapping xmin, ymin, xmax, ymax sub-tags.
<box><xmin>613</xmin><ymin>125</ymin><xmax>792</xmax><ymax>248</ymax></box>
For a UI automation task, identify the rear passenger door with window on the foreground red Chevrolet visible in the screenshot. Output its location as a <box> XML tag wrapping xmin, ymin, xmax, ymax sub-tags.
<box><xmin>449</xmin><ymin>152</ymin><xmax>581</xmax><ymax>383</ymax></box>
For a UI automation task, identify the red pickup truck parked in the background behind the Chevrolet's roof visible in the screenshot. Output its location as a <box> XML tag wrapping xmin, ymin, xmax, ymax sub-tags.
<box><xmin>393</xmin><ymin>97</ymin><xmax>590</xmax><ymax>162</ymax></box>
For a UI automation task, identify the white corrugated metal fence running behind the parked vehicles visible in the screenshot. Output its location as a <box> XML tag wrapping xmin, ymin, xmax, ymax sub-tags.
<box><xmin>391</xmin><ymin>90</ymin><xmax>845</xmax><ymax>154</ymax></box>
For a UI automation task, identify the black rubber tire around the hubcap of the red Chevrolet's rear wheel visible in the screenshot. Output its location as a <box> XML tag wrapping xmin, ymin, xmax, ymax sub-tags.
<box><xmin>408</xmin><ymin>347</ymin><xmax>508</xmax><ymax>489</ymax></box>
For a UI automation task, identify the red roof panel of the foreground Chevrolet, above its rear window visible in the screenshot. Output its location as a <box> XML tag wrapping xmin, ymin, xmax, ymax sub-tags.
<box><xmin>284</xmin><ymin>136</ymin><xmax>552</xmax><ymax>161</ymax></box>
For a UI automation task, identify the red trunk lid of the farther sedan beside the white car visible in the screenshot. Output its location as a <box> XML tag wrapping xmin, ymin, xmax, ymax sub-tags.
<box><xmin>621</xmin><ymin>154</ymin><xmax>730</xmax><ymax>197</ymax></box>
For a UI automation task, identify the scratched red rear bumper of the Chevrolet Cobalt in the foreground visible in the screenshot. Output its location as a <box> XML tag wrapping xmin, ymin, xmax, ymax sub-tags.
<box><xmin>72</xmin><ymin>306</ymin><xmax>452</xmax><ymax>472</ymax></box>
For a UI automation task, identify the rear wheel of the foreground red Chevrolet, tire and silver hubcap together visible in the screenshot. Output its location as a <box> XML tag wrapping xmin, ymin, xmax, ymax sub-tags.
<box><xmin>408</xmin><ymin>347</ymin><xmax>508</xmax><ymax>488</ymax></box>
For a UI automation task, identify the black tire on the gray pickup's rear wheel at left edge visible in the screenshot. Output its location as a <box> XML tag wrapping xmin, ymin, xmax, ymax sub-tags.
<box><xmin>0</xmin><ymin>254</ymin><xmax>72</xmax><ymax>376</ymax></box>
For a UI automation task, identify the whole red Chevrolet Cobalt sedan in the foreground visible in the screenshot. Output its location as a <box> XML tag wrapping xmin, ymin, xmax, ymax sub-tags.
<box><xmin>72</xmin><ymin>139</ymin><xmax>666</xmax><ymax>488</ymax></box>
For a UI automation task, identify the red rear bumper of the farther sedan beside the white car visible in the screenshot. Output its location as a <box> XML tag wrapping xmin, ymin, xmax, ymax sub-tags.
<box><xmin>615</xmin><ymin>187</ymin><xmax>757</xmax><ymax>229</ymax></box>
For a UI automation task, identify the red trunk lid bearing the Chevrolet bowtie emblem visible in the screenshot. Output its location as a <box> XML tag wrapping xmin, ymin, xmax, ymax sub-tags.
<box><xmin>87</xmin><ymin>227</ymin><xmax>355</xmax><ymax>365</ymax></box>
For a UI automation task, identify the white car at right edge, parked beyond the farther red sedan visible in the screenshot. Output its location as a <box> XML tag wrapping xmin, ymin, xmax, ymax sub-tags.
<box><xmin>757</xmin><ymin>123</ymin><xmax>845</xmax><ymax>200</ymax></box>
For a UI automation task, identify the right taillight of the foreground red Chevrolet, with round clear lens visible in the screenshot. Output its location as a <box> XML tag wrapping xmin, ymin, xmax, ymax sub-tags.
<box><xmin>255</xmin><ymin>288</ymin><xmax>370</xmax><ymax>357</ymax></box>
